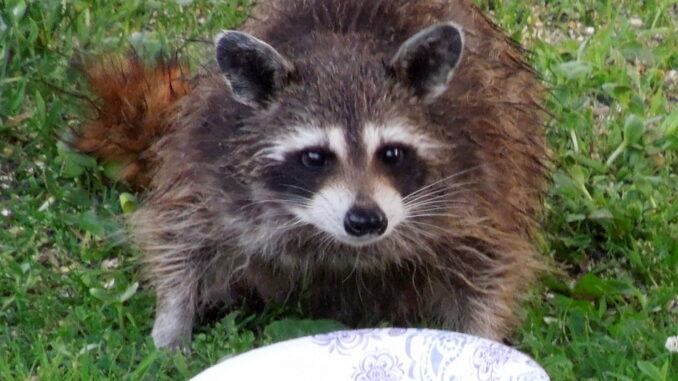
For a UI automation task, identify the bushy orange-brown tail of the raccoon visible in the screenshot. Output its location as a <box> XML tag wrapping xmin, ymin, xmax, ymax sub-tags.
<box><xmin>68</xmin><ymin>55</ymin><xmax>193</xmax><ymax>188</ymax></box>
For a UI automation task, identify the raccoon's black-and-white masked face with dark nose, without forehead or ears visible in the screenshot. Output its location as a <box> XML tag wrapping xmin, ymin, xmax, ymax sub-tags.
<box><xmin>263</xmin><ymin>122</ymin><xmax>444</xmax><ymax>246</ymax></box>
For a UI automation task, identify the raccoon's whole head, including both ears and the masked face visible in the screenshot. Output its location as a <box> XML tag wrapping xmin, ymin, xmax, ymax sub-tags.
<box><xmin>216</xmin><ymin>23</ymin><xmax>463</xmax><ymax>247</ymax></box>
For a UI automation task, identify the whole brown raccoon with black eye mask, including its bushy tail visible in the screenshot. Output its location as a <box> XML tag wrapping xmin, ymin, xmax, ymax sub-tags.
<box><xmin>71</xmin><ymin>0</ymin><xmax>548</xmax><ymax>348</ymax></box>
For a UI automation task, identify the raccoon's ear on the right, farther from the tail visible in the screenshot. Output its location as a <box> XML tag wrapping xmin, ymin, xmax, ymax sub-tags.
<box><xmin>389</xmin><ymin>23</ymin><xmax>464</xmax><ymax>101</ymax></box>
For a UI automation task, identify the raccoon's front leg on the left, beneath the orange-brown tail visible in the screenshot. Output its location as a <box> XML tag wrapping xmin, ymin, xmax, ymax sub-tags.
<box><xmin>130</xmin><ymin>193</ymin><xmax>215</xmax><ymax>349</ymax></box>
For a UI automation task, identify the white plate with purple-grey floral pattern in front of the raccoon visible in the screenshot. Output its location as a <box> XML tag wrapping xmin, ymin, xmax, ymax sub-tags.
<box><xmin>193</xmin><ymin>328</ymin><xmax>549</xmax><ymax>381</ymax></box>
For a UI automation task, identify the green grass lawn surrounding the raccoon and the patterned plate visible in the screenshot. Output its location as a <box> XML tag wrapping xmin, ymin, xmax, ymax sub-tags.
<box><xmin>0</xmin><ymin>0</ymin><xmax>678</xmax><ymax>381</ymax></box>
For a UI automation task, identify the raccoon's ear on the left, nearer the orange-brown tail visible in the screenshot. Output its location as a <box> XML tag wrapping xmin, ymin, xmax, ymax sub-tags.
<box><xmin>214</xmin><ymin>30</ymin><xmax>293</xmax><ymax>106</ymax></box>
